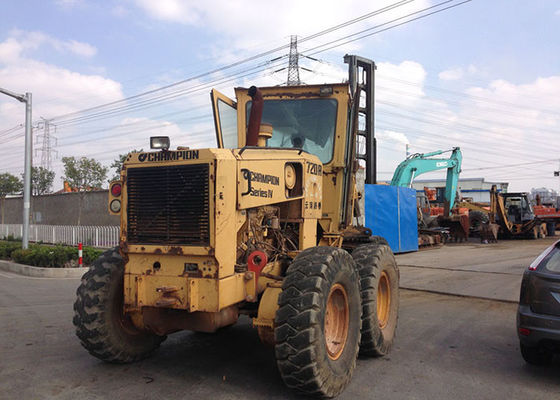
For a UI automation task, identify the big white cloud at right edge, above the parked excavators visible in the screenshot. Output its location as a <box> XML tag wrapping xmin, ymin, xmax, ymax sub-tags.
<box><xmin>442</xmin><ymin>76</ymin><xmax>560</xmax><ymax>191</ymax></box>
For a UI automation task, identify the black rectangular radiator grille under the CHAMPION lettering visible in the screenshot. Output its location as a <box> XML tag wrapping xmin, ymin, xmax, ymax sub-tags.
<box><xmin>126</xmin><ymin>164</ymin><xmax>210</xmax><ymax>246</ymax></box>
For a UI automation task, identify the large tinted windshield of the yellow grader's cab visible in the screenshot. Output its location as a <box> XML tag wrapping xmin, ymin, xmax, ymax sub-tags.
<box><xmin>247</xmin><ymin>99</ymin><xmax>337</xmax><ymax>164</ymax></box>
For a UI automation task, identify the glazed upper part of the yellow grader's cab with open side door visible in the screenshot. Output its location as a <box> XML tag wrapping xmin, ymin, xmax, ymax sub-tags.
<box><xmin>211</xmin><ymin>84</ymin><xmax>348</xmax><ymax>164</ymax></box>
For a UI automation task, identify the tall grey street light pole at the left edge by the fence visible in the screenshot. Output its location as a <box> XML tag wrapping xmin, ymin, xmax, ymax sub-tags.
<box><xmin>0</xmin><ymin>88</ymin><xmax>33</xmax><ymax>249</ymax></box>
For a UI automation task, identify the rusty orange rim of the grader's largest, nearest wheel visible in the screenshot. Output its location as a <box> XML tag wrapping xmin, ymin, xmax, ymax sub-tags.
<box><xmin>325</xmin><ymin>283</ymin><xmax>350</xmax><ymax>360</ymax></box>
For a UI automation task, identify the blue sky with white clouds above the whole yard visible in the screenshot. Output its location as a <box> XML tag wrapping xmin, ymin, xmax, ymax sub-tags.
<box><xmin>0</xmin><ymin>0</ymin><xmax>560</xmax><ymax>191</ymax></box>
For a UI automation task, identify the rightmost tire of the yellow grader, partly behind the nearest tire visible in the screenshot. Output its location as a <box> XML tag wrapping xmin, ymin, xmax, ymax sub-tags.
<box><xmin>352</xmin><ymin>243</ymin><xmax>400</xmax><ymax>357</ymax></box>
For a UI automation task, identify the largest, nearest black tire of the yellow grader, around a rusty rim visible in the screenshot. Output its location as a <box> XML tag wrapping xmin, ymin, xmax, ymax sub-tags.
<box><xmin>274</xmin><ymin>247</ymin><xmax>361</xmax><ymax>397</ymax></box>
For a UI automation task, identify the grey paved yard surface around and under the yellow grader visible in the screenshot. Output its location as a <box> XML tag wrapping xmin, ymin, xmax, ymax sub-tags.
<box><xmin>0</xmin><ymin>241</ymin><xmax>560</xmax><ymax>400</ymax></box>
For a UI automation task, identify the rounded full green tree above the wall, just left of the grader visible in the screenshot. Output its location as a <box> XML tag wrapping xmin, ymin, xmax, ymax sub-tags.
<box><xmin>62</xmin><ymin>157</ymin><xmax>108</xmax><ymax>225</ymax></box>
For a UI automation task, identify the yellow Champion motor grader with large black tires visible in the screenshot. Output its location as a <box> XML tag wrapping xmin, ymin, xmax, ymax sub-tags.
<box><xmin>74</xmin><ymin>56</ymin><xmax>399</xmax><ymax>397</ymax></box>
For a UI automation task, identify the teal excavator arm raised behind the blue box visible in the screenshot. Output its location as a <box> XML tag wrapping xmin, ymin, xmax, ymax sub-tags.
<box><xmin>391</xmin><ymin>147</ymin><xmax>463</xmax><ymax>215</ymax></box>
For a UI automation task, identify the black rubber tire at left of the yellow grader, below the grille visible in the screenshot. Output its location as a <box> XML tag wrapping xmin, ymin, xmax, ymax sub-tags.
<box><xmin>73</xmin><ymin>248</ymin><xmax>166</xmax><ymax>364</ymax></box>
